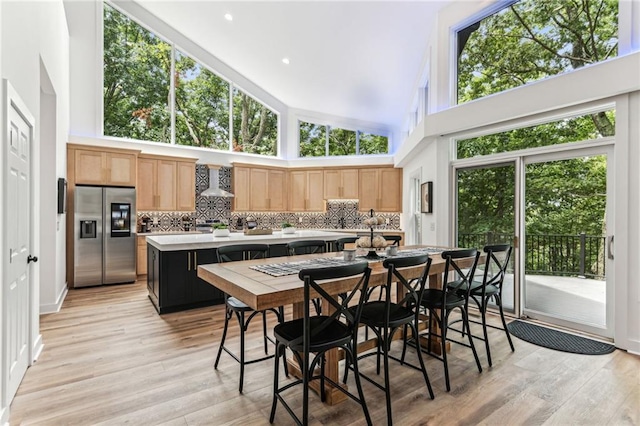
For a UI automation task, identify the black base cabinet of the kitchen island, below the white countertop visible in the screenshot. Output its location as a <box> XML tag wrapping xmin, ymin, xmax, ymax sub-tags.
<box><xmin>147</xmin><ymin>245</ymin><xmax>224</xmax><ymax>314</ymax></box>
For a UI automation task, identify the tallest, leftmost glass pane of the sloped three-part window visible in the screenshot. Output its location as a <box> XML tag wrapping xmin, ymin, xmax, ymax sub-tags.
<box><xmin>103</xmin><ymin>4</ymin><xmax>171</xmax><ymax>142</ymax></box>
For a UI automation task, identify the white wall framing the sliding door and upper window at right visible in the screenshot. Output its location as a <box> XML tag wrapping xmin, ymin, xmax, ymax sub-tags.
<box><xmin>395</xmin><ymin>0</ymin><xmax>640</xmax><ymax>353</ymax></box>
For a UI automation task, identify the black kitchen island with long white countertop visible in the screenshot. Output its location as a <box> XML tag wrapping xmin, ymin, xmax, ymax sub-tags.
<box><xmin>147</xmin><ymin>229</ymin><xmax>349</xmax><ymax>314</ymax></box>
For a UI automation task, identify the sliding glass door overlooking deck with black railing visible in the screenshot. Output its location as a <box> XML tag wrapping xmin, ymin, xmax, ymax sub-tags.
<box><xmin>454</xmin><ymin>145</ymin><xmax>613</xmax><ymax>337</ymax></box>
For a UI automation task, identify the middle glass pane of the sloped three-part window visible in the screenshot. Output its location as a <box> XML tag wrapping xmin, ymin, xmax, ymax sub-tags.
<box><xmin>175</xmin><ymin>50</ymin><xmax>229</xmax><ymax>151</ymax></box>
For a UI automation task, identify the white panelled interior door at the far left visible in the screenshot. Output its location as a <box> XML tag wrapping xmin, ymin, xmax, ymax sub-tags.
<box><xmin>2</xmin><ymin>82</ymin><xmax>34</xmax><ymax>406</ymax></box>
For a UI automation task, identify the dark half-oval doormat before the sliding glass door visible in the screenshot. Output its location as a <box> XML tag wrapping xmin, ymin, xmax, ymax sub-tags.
<box><xmin>507</xmin><ymin>320</ymin><xmax>616</xmax><ymax>355</ymax></box>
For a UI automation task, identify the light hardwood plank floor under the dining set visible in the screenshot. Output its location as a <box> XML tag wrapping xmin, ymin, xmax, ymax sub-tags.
<box><xmin>10</xmin><ymin>282</ymin><xmax>640</xmax><ymax>425</ymax></box>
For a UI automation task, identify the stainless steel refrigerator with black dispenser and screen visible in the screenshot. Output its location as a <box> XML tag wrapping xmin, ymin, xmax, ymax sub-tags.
<box><xmin>74</xmin><ymin>186</ymin><xmax>136</xmax><ymax>287</ymax></box>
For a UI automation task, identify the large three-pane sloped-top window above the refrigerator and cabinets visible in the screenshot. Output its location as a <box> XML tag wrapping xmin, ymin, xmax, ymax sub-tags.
<box><xmin>104</xmin><ymin>4</ymin><xmax>278</xmax><ymax>156</ymax></box>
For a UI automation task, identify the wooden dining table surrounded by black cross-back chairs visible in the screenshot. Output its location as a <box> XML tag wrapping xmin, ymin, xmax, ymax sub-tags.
<box><xmin>198</xmin><ymin>246</ymin><xmax>468</xmax><ymax>405</ymax></box>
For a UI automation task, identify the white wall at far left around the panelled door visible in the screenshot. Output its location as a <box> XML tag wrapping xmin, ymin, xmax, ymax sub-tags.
<box><xmin>0</xmin><ymin>1</ymin><xmax>69</xmax><ymax>370</ymax></box>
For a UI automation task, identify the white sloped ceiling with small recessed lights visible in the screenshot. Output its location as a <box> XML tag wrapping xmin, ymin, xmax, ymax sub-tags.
<box><xmin>138</xmin><ymin>0</ymin><xmax>450</xmax><ymax>129</ymax></box>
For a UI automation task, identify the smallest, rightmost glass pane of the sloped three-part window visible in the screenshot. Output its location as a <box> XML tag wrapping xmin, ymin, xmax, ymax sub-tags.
<box><xmin>233</xmin><ymin>88</ymin><xmax>278</xmax><ymax>155</ymax></box>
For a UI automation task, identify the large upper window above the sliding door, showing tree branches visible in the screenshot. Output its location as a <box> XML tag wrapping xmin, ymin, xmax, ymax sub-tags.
<box><xmin>457</xmin><ymin>0</ymin><xmax>618</xmax><ymax>103</ymax></box>
